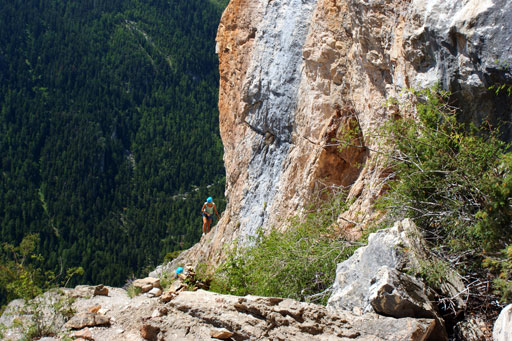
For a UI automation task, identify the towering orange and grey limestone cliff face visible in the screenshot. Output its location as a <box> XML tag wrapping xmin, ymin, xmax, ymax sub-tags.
<box><xmin>173</xmin><ymin>0</ymin><xmax>512</xmax><ymax>262</ymax></box>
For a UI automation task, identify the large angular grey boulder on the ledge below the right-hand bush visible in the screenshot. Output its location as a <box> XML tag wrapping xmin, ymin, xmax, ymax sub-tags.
<box><xmin>328</xmin><ymin>219</ymin><xmax>464</xmax><ymax>340</ymax></box>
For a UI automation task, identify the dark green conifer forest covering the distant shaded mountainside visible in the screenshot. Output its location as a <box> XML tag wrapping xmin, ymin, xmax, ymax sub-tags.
<box><xmin>0</xmin><ymin>0</ymin><xmax>227</xmax><ymax>303</ymax></box>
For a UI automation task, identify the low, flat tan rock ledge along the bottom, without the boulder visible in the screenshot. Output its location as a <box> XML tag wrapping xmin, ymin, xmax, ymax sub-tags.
<box><xmin>3</xmin><ymin>286</ymin><xmax>435</xmax><ymax>340</ymax></box>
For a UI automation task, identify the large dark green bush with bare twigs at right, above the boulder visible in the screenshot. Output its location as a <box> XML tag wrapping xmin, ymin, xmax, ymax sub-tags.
<box><xmin>380</xmin><ymin>89</ymin><xmax>512</xmax><ymax>300</ymax></box>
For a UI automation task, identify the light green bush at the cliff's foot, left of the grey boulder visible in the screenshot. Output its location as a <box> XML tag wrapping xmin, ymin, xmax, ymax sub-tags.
<box><xmin>210</xmin><ymin>191</ymin><xmax>362</xmax><ymax>303</ymax></box>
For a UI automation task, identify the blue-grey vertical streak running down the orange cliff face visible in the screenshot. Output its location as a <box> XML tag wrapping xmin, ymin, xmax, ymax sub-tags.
<box><xmin>233</xmin><ymin>0</ymin><xmax>316</xmax><ymax>239</ymax></box>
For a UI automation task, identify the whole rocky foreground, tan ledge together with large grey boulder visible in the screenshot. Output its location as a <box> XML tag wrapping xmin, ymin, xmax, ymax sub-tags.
<box><xmin>0</xmin><ymin>220</ymin><xmax>512</xmax><ymax>341</ymax></box>
